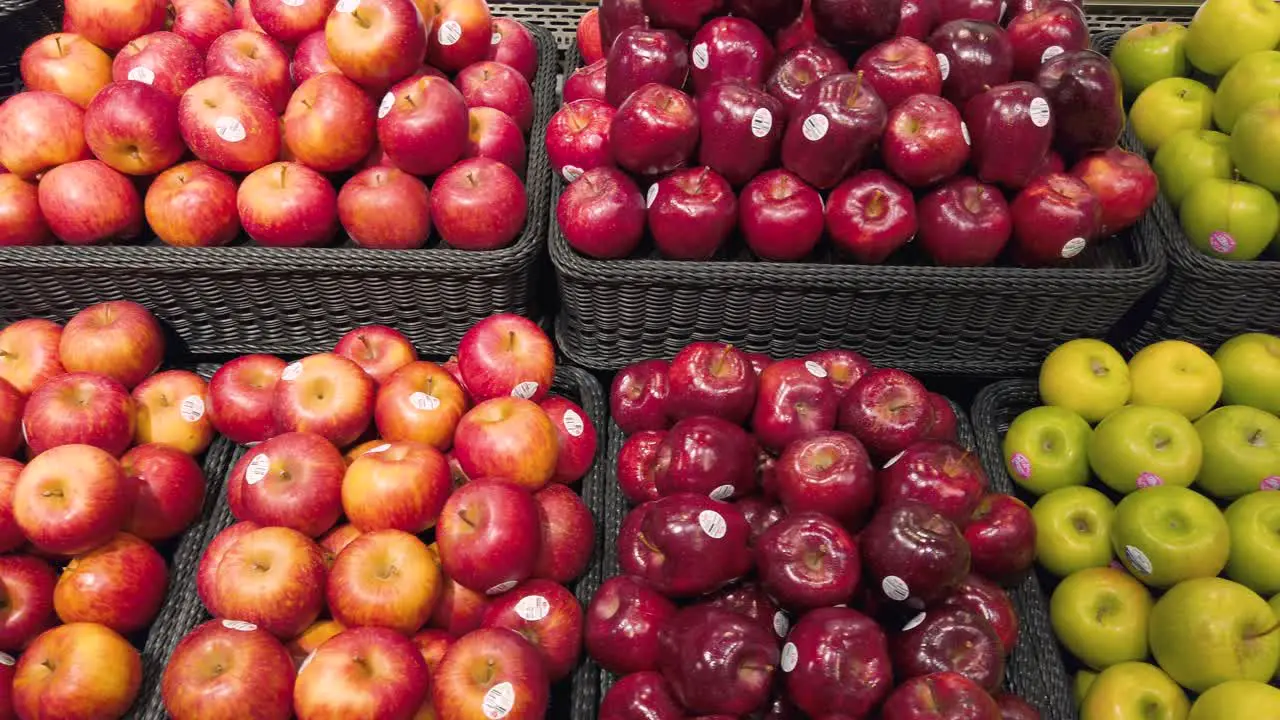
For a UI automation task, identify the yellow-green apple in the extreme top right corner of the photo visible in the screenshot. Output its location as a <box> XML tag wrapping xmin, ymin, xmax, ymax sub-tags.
<box><xmin>1185</xmin><ymin>0</ymin><xmax>1280</xmax><ymax>76</ymax></box>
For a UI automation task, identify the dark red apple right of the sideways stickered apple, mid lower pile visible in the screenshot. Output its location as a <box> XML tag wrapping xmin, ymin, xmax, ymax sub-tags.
<box><xmin>755</xmin><ymin>511</ymin><xmax>861</xmax><ymax>612</ymax></box>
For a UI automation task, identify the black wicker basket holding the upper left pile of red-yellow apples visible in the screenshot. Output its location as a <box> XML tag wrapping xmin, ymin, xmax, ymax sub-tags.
<box><xmin>0</xmin><ymin>18</ymin><xmax>558</xmax><ymax>355</ymax></box>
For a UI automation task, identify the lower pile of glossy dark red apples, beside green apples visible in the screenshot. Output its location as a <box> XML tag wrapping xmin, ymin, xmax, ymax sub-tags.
<box><xmin>585</xmin><ymin>342</ymin><xmax>1039</xmax><ymax>720</ymax></box>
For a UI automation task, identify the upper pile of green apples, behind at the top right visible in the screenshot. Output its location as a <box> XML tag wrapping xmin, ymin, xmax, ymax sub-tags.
<box><xmin>1111</xmin><ymin>0</ymin><xmax>1280</xmax><ymax>260</ymax></box>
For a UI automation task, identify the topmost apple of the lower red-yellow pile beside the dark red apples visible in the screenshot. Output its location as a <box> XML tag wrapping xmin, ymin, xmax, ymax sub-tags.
<box><xmin>458</xmin><ymin>314</ymin><xmax>556</xmax><ymax>402</ymax></box>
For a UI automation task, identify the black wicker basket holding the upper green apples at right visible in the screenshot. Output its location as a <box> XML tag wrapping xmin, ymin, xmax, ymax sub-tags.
<box><xmin>1093</xmin><ymin>31</ymin><xmax>1280</xmax><ymax>351</ymax></box>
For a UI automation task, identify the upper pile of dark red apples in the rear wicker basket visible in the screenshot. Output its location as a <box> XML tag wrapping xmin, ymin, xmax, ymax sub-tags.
<box><xmin>547</xmin><ymin>0</ymin><xmax>1157</xmax><ymax>266</ymax></box>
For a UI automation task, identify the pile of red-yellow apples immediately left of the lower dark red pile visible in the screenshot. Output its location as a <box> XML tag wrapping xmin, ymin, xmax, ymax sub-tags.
<box><xmin>154</xmin><ymin>315</ymin><xmax>596</xmax><ymax>720</ymax></box>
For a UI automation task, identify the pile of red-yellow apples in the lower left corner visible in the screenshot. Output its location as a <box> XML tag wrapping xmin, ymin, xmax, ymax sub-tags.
<box><xmin>0</xmin><ymin>301</ymin><xmax>214</xmax><ymax>720</ymax></box>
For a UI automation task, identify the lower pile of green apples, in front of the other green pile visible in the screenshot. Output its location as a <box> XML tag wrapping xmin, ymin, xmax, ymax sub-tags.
<box><xmin>1004</xmin><ymin>330</ymin><xmax>1280</xmax><ymax>720</ymax></box>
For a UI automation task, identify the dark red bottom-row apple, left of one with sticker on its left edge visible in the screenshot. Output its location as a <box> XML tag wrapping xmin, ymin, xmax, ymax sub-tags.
<box><xmin>658</xmin><ymin>606</ymin><xmax>778</xmax><ymax>716</ymax></box>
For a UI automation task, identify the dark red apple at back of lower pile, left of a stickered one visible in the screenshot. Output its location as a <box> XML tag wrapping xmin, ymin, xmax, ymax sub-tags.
<box><xmin>667</xmin><ymin>342</ymin><xmax>759</xmax><ymax>424</ymax></box>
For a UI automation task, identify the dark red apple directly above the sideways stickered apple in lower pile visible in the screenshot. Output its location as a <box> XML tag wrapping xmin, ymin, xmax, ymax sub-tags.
<box><xmin>654</xmin><ymin>415</ymin><xmax>755</xmax><ymax>500</ymax></box>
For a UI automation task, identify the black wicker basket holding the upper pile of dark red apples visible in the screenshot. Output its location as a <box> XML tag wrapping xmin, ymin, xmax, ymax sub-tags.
<box><xmin>549</xmin><ymin>47</ymin><xmax>1165</xmax><ymax>377</ymax></box>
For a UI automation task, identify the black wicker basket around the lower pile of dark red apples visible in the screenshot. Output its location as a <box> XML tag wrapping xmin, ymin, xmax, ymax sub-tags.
<box><xmin>600</xmin><ymin>394</ymin><xmax>1075</xmax><ymax>720</ymax></box>
